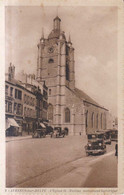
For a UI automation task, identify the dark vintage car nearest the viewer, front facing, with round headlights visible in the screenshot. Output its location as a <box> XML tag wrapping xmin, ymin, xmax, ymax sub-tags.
<box><xmin>85</xmin><ymin>132</ymin><xmax>106</xmax><ymax>156</ymax></box>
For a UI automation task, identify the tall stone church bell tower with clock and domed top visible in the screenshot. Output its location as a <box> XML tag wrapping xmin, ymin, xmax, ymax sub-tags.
<box><xmin>37</xmin><ymin>16</ymin><xmax>75</xmax><ymax>126</ymax></box>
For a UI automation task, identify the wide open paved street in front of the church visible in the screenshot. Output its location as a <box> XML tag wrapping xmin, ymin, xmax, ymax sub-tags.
<box><xmin>6</xmin><ymin>136</ymin><xmax>117</xmax><ymax>187</ymax></box>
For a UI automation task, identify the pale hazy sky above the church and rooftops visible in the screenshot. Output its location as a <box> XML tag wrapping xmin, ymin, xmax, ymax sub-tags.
<box><xmin>5</xmin><ymin>6</ymin><xmax>118</xmax><ymax>116</ymax></box>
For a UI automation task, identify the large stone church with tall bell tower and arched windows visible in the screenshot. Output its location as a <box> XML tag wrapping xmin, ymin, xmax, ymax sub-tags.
<box><xmin>37</xmin><ymin>16</ymin><xmax>108</xmax><ymax>135</ymax></box>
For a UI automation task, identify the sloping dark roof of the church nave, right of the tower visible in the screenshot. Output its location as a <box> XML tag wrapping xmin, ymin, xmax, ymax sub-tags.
<box><xmin>74</xmin><ymin>88</ymin><xmax>107</xmax><ymax>110</ymax></box>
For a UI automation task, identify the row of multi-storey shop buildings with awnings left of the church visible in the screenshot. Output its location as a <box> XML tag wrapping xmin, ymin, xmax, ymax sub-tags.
<box><xmin>5</xmin><ymin>64</ymin><xmax>47</xmax><ymax>135</ymax></box>
